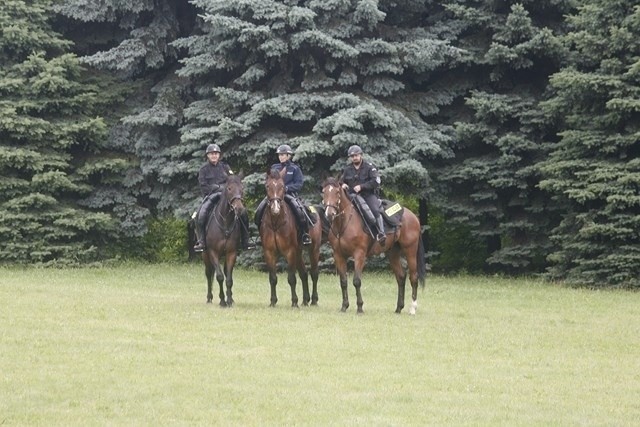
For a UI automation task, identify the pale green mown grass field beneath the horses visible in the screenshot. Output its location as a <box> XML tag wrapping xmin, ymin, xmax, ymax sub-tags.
<box><xmin>0</xmin><ymin>264</ymin><xmax>640</xmax><ymax>426</ymax></box>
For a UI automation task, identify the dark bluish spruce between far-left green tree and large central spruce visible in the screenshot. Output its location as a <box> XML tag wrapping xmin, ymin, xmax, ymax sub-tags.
<box><xmin>56</xmin><ymin>0</ymin><xmax>195</xmax><ymax>226</ymax></box>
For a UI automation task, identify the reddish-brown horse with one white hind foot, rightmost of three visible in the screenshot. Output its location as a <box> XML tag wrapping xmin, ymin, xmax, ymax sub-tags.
<box><xmin>322</xmin><ymin>178</ymin><xmax>426</xmax><ymax>314</ymax></box>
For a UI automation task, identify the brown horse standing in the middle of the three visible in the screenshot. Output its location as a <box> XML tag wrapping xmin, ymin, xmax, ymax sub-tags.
<box><xmin>259</xmin><ymin>170</ymin><xmax>322</xmax><ymax>307</ymax></box>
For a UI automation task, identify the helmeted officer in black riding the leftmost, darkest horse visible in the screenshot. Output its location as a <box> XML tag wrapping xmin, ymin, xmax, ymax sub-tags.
<box><xmin>193</xmin><ymin>144</ymin><xmax>252</xmax><ymax>252</ymax></box>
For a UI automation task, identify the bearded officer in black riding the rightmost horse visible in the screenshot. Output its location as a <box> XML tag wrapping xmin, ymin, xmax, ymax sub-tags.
<box><xmin>340</xmin><ymin>145</ymin><xmax>386</xmax><ymax>245</ymax></box>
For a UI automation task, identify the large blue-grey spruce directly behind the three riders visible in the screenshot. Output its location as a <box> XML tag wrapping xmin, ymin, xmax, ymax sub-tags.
<box><xmin>172</xmin><ymin>0</ymin><xmax>459</xmax><ymax>217</ymax></box>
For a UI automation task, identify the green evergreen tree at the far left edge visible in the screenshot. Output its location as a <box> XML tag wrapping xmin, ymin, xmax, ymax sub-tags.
<box><xmin>0</xmin><ymin>0</ymin><xmax>120</xmax><ymax>264</ymax></box>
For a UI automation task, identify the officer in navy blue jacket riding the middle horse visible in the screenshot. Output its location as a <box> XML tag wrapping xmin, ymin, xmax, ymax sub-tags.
<box><xmin>255</xmin><ymin>144</ymin><xmax>311</xmax><ymax>245</ymax></box>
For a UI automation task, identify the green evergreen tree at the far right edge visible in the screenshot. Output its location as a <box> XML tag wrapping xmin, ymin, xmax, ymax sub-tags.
<box><xmin>541</xmin><ymin>0</ymin><xmax>640</xmax><ymax>288</ymax></box>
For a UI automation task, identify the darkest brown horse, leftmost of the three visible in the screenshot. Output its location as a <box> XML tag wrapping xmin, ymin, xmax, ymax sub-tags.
<box><xmin>202</xmin><ymin>175</ymin><xmax>245</xmax><ymax>307</ymax></box>
